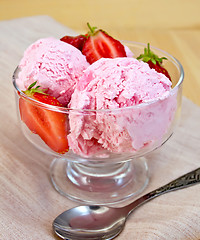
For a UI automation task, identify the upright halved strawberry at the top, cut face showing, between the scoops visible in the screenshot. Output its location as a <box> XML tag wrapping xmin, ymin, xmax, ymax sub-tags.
<box><xmin>82</xmin><ymin>24</ymin><xmax>126</xmax><ymax>64</ymax></box>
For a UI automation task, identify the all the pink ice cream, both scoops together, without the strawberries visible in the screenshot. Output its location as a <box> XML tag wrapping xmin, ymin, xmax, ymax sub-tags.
<box><xmin>16</xmin><ymin>34</ymin><xmax>176</xmax><ymax>157</ymax></box>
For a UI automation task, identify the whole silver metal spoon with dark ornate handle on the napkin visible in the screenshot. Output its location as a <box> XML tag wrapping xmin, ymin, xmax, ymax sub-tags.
<box><xmin>53</xmin><ymin>168</ymin><xmax>200</xmax><ymax>240</ymax></box>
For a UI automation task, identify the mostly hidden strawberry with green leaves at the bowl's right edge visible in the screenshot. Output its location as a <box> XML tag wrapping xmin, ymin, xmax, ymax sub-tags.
<box><xmin>137</xmin><ymin>43</ymin><xmax>171</xmax><ymax>81</ymax></box>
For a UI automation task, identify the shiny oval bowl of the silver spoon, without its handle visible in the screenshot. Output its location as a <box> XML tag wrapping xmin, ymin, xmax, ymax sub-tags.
<box><xmin>53</xmin><ymin>206</ymin><xmax>126</xmax><ymax>239</ymax></box>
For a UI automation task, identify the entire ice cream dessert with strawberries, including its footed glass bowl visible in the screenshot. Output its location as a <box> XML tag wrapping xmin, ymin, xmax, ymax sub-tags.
<box><xmin>13</xmin><ymin>23</ymin><xmax>184</xmax><ymax>204</ymax></box>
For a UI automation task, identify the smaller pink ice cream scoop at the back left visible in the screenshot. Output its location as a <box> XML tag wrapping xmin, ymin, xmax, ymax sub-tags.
<box><xmin>17</xmin><ymin>38</ymin><xmax>89</xmax><ymax>105</ymax></box>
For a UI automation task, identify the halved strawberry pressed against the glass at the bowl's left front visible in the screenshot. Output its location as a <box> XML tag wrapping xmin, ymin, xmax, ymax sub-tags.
<box><xmin>19</xmin><ymin>82</ymin><xmax>69</xmax><ymax>154</ymax></box>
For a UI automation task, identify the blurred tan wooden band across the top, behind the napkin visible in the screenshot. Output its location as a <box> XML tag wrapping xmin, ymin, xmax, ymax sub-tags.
<box><xmin>0</xmin><ymin>0</ymin><xmax>200</xmax><ymax>31</ymax></box>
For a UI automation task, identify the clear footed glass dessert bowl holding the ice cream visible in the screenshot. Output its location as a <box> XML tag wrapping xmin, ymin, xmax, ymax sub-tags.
<box><xmin>13</xmin><ymin>42</ymin><xmax>184</xmax><ymax>204</ymax></box>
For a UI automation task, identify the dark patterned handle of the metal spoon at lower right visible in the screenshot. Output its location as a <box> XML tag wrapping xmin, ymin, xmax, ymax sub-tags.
<box><xmin>125</xmin><ymin>168</ymin><xmax>200</xmax><ymax>214</ymax></box>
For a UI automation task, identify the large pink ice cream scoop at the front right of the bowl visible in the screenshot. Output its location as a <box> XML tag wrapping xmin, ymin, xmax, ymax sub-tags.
<box><xmin>68</xmin><ymin>58</ymin><xmax>176</xmax><ymax>156</ymax></box>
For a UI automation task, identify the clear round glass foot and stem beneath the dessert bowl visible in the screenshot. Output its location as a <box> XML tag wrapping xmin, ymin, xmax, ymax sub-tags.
<box><xmin>50</xmin><ymin>157</ymin><xmax>149</xmax><ymax>205</ymax></box>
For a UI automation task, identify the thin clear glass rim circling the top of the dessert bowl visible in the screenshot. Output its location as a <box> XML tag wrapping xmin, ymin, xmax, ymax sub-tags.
<box><xmin>12</xmin><ymin>40</ymin><xmax>184</xmax><ymax>113</ymax></box>
